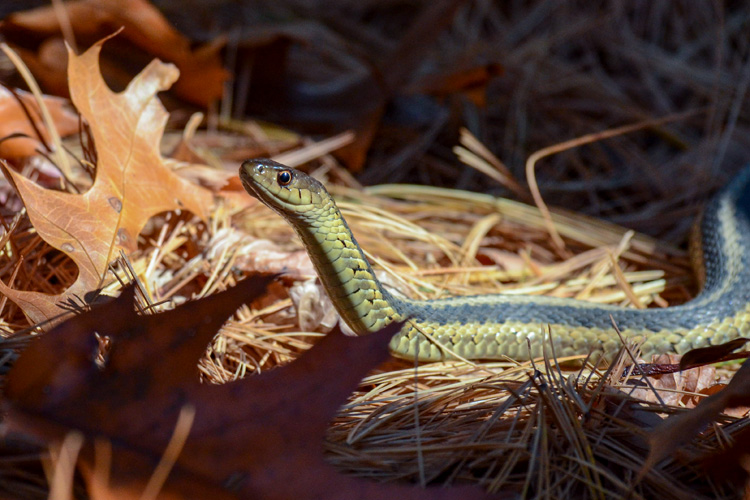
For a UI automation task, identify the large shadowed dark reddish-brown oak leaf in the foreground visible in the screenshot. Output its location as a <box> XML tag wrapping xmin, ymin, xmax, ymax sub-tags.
<box><xmin>5</xmin><ymin>276</ymin><xmax>488</xmax><ymax>500</ymax></box>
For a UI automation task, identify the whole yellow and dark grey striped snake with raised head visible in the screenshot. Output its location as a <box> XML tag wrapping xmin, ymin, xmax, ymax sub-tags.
<box><xmin>240</xmin><ymin>159</ymin><xmax>750</xmax><ymax>360</ymax></box>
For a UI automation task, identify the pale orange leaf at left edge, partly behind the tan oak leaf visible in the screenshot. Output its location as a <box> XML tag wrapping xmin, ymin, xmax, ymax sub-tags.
<box><xmin>0</xmin><ymin>86</ymin><xmax>78</xmax><ymax>158</ymax></box>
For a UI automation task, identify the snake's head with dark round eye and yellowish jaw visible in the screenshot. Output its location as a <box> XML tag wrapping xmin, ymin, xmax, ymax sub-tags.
<box><xmin>240</xmin><ymin>158</ymin><xmax>330</xmax><ymax>218</ymax></box>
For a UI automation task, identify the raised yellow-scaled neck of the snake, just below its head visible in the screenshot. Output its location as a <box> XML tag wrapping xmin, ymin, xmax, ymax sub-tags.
<box><xmin>287</xmin><ymin>193</ymin><xmax>406</xmax><ymax>335</ymax></box>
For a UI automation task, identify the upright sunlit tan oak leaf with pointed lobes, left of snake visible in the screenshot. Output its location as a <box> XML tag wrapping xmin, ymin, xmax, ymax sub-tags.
<box><xmin>0</xmin><ymin>40</ymin><xmax>213</xmax><ymax>323</ymax></box>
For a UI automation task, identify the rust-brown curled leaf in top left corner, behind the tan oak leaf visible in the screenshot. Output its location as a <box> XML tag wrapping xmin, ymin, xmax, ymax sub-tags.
<box><xmin>3</xmin><ymin>0</ymin><xmax>229</xmax><ymax>107</ymax></box>
